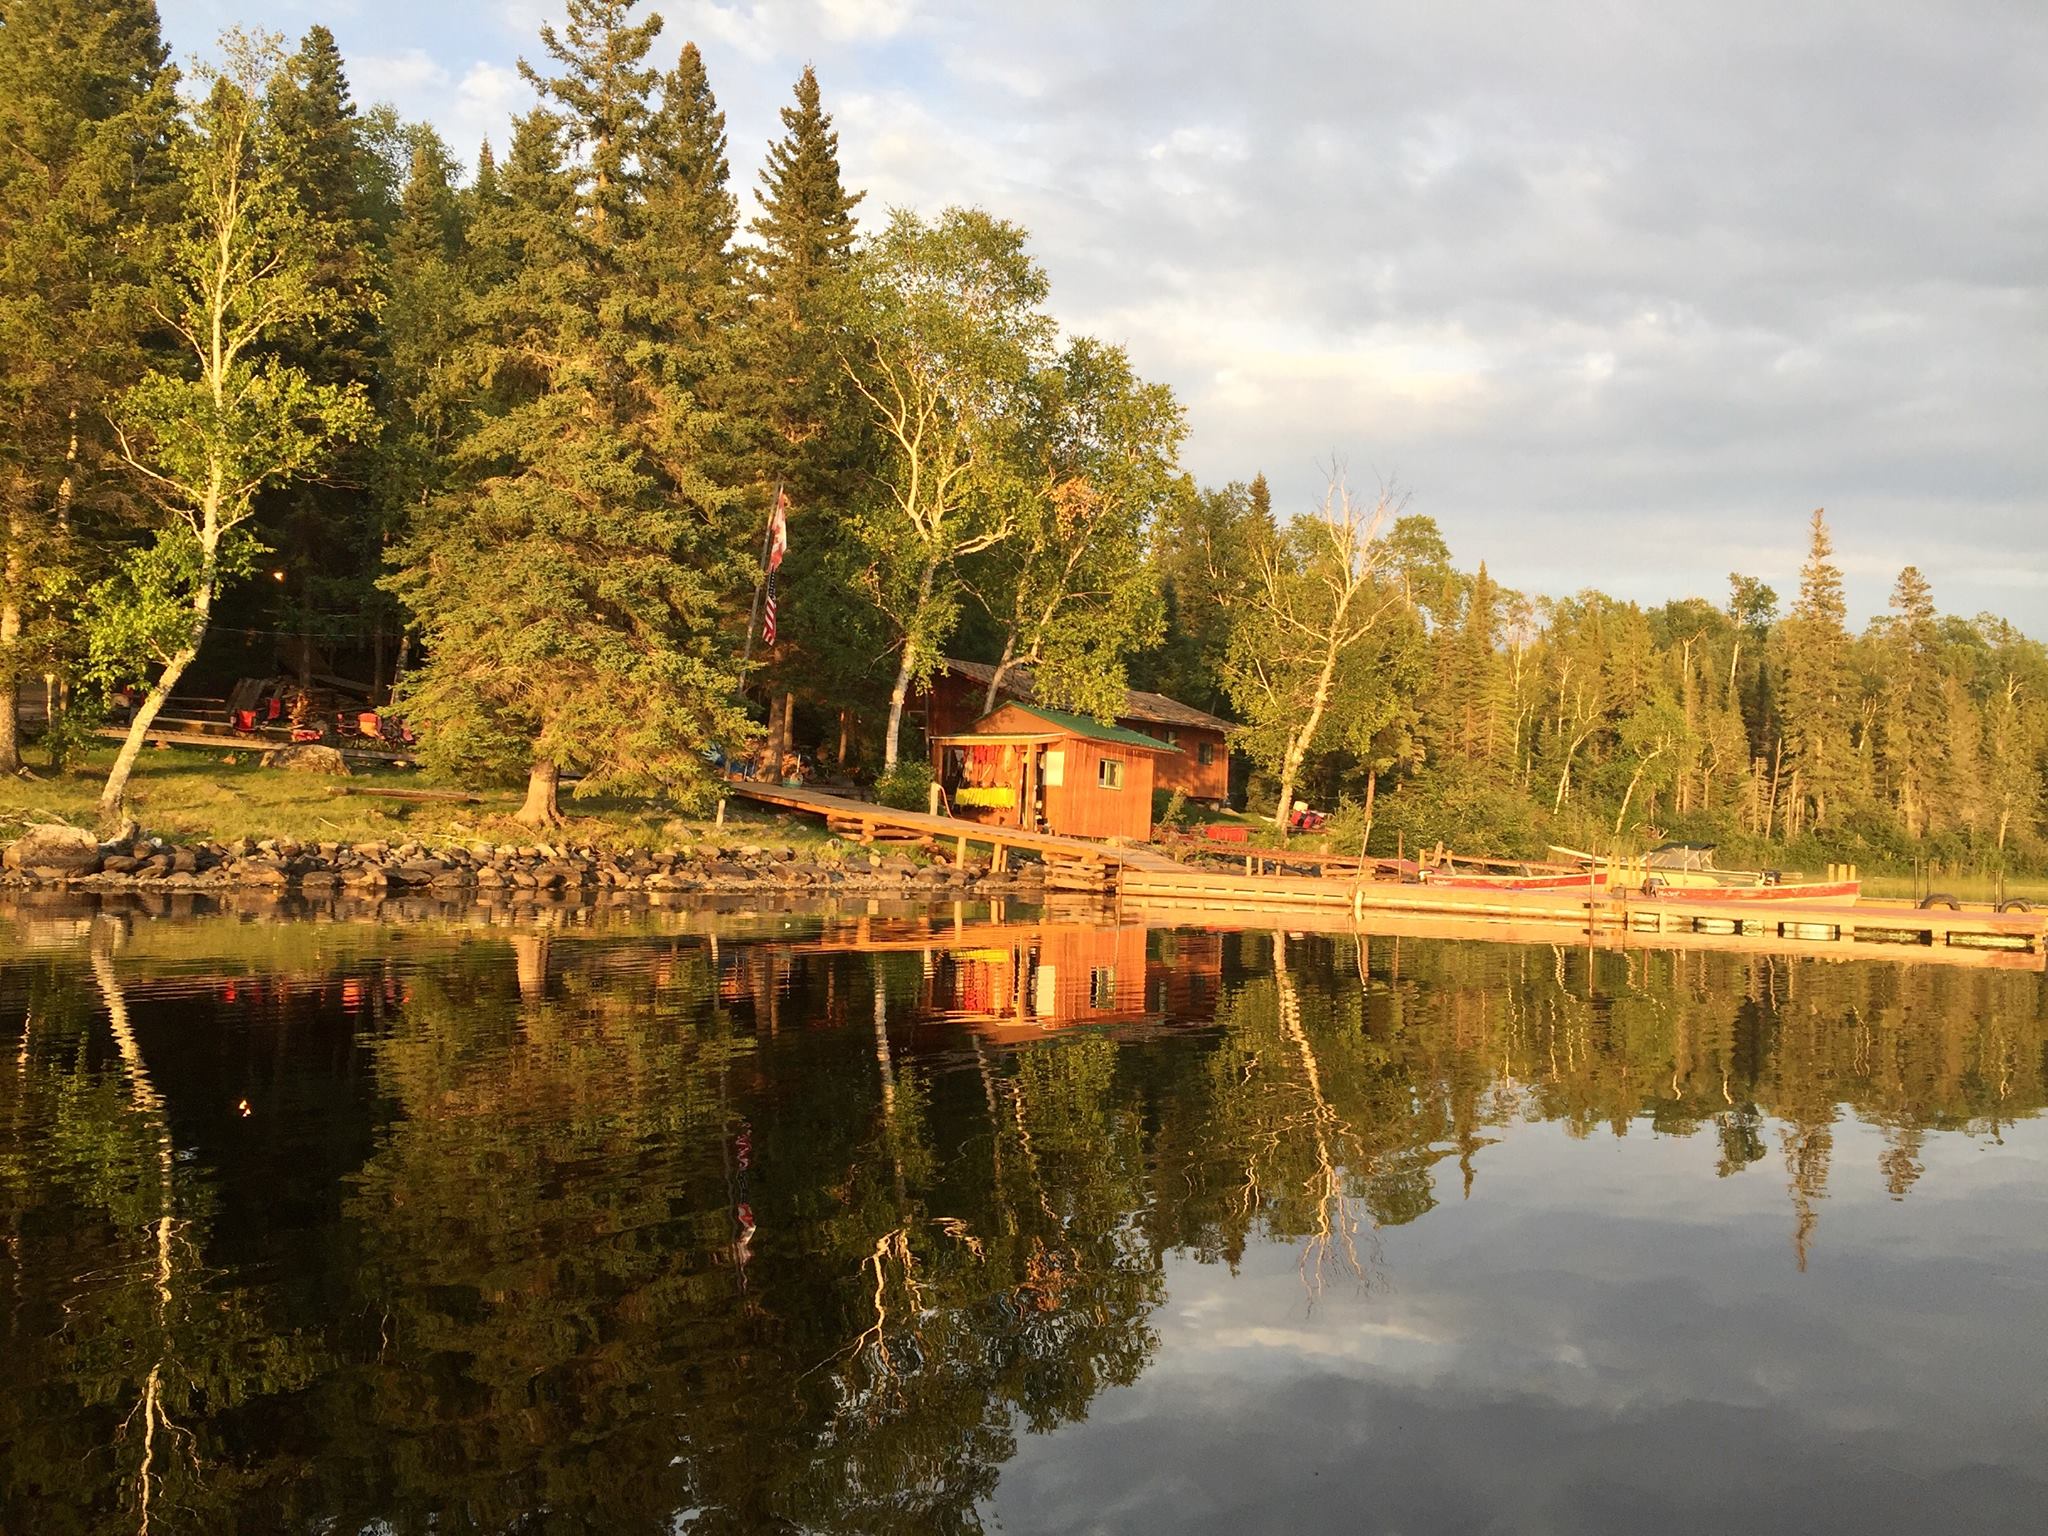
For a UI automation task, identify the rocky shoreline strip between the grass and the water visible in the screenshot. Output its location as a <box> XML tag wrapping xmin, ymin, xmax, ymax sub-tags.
<box><xmin>0</xmin><ymin>827</ymin><xmax>1044</xmax><ymax>899</ymax></box>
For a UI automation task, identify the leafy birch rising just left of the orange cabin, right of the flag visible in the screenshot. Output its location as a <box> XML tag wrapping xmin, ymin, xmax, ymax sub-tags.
<box><xmin>842</xmin><ymin>209</ymin><xmax>1053</xmax><ymax>772</ymax></box>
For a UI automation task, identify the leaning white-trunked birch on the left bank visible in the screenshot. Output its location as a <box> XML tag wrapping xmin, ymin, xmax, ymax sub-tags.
<box><xmin>88</xmin><ymin>33</ymin><xmax>371</xmax><ymax>834</ymax></box>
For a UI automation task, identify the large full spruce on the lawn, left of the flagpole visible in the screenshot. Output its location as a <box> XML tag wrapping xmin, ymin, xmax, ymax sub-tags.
<box><xmin>391</xmin><ymin>0</ymin><xmax>745</xmax><ymax>823</ymax></box>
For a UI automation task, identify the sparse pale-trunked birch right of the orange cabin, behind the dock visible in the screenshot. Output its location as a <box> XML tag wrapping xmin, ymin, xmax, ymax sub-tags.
<box><xmin>1225</xmin><ymin>475</ymin><xmax>1405</xmax><ymax>831</ymax></box>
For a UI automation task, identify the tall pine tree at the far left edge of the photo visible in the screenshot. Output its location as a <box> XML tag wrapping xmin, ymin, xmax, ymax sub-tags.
<box><xmin>0</xmin><ymin>0</ymin><xmax>176</xmax><ymax>772</ymax></box>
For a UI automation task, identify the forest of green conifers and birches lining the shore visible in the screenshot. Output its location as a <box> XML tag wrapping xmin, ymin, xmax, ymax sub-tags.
<box><xmin>0</xmin><ymin>0</ymin><xmax>2048</xmax><ymax>870</ymax></box>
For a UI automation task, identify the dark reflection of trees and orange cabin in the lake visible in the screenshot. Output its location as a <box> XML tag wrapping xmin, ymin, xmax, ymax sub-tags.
<box><xmin>0</xmin><ymin>915</ymin><xmax>2048</xmax><ymax>1532</ymax></box>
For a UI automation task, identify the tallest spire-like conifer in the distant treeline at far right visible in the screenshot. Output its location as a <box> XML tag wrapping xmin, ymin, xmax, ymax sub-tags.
<box><xmin>1782</xmin><ymin>510</ymin><xmax>1855</xmax><ymax>829</ymax></box>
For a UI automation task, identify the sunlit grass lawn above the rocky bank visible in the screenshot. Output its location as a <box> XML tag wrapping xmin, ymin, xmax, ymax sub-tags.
<box><xmin>0</xmin><ymin>745</ymin><xmax>840</xmax><ymax>852</ymax></box>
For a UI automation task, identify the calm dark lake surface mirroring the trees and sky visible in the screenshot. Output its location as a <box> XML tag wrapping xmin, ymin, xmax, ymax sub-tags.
<box><xmin>0</xmin><ymin>903</ymin><xmax>2048</xmax><ymax>1536</ymax></box>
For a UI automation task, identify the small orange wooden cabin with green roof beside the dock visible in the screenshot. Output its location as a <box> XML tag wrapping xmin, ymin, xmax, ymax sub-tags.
<box><xmin>932</xmin><ymin>705</ymin><xmax>1178</xmax><ymax>842</ymax></box>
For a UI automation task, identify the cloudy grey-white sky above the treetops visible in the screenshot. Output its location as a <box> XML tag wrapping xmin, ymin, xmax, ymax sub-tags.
<box><xmin>162</xmin><ymin>0</ymin><xmax>2048</xmax><ymax>635</ymax></box>
